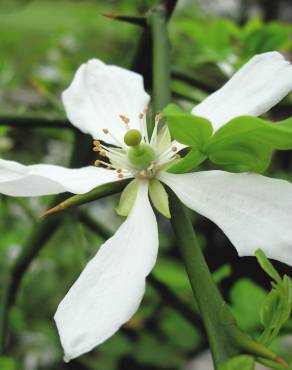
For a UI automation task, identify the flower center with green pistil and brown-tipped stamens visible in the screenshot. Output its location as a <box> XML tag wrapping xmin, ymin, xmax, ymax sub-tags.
<box><xmin>93</xmin><ymin>109</ymin><xmax>178</xmax><ymax>179</ymax></box>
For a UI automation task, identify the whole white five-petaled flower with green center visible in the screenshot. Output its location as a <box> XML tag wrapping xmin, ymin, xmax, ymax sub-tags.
<box><xmin>0</xmin><ymin>52</ymin><xmax>292</xmax><ymax>360</ymax></box>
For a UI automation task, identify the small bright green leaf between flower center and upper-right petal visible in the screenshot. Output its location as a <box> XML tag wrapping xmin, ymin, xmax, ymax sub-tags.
<box><xmin>163</xmin><ymin>104</ymin><xmax>213</xmax><ymax>150</ymax></box>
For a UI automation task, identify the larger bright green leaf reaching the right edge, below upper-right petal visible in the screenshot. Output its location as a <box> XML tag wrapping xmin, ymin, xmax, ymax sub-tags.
<box><xmin>205</xmin><ymin>116</ymin><xmax>292</xmax><ymax>172</ymax></box>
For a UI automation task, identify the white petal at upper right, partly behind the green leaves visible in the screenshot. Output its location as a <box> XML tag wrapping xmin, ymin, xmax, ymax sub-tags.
<box><xmin>192</xmin><ymin>52</ymin><xmax>292</xmax><ymax>129</ymax></box>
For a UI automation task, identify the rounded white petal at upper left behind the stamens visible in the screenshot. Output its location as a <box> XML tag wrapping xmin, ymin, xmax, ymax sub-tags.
<box><xmin>62</xmin><ymin>59</ymin><xmax>150</xmax><ymax>144</ymax></box>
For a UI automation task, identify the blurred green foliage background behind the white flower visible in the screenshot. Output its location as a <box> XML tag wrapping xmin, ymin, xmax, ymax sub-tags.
<box><xmin>0</xmin><ymin>0</ymin><xmax>292</xmax><ymax>370</ymax></box>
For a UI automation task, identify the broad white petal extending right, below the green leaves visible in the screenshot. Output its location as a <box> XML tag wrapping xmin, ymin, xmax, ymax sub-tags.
<box><xmin>161</xmin><ymin>171</ymin><xmax>292</xmax><ymax>265</ymax></box>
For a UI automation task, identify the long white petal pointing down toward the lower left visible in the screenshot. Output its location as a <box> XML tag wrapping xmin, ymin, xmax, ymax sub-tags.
<box><xmin>55</xmin><ymin>181</ymin><xmax>158</xmax><ymax>361</ymax></box>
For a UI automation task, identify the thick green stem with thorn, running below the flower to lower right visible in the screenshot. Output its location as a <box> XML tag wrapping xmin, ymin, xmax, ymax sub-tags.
<box><xmin>169</xmin><ymin>191</ymin><xmax>281</xmax><ymax>369</ymax></box>
